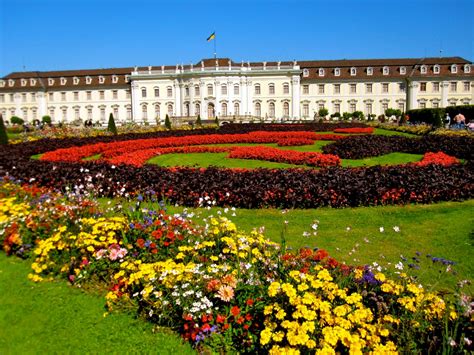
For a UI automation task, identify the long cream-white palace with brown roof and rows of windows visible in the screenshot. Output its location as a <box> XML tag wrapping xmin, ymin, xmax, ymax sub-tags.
<box><xmin>0</xmin><ymin>57</ymin><xmax>474</xmax><ymax>124</ymax></box>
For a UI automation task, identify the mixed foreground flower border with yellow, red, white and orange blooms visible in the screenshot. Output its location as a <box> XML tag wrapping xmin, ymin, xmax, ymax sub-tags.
<box><xmin>0</xmin><ymin>179</ymin><xmax>472</xmax><ymax>353</ymax></box>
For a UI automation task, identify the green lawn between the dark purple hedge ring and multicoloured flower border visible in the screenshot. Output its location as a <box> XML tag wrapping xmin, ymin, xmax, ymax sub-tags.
<box><xmin>164</xmin><ymin>200</ymin><xmax>474</xmax><ymax>293</ymax></box>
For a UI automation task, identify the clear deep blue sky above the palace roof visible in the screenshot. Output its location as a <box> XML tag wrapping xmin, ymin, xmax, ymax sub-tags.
<box><xmin>0</xmin><ymin>0</ymin><xmax>474</xmax><ymax>76</ymax></box>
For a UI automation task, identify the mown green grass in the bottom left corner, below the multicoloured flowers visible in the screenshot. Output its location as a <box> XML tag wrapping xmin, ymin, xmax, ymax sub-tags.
<box><xmin>0</xmin><ymin>253</ymin><xmax>194</xmax><ymax>354</ymax></box>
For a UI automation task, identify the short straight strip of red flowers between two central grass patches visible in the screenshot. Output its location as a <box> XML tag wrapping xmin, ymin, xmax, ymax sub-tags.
<box><xmin>229</xmin><ymin>147</ymin><xmax>341</xmax><ymax>167</ymax></box>
